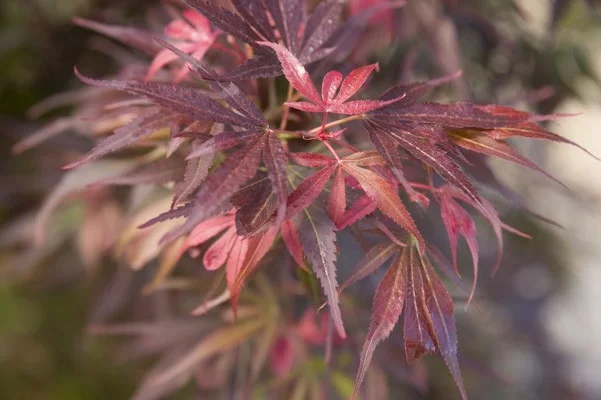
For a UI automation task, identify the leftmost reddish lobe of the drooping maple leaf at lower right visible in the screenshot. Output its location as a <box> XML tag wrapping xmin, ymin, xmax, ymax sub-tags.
<box><xmin>351</xmin><ymin>249</ymin><xmax>411</xmax><ymax>399</ymax></box>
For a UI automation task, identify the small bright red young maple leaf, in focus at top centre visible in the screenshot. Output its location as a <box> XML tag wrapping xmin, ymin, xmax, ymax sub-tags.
<box><xmin>258</xmin><ymin>42</ymin><xmax>405</xmax><ymax>115</ymax></box>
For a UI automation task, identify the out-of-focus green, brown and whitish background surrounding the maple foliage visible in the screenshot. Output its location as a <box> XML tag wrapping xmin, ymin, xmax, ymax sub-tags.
<box><xmin>0</xmin><ymin>0</ymin><xmax>601</xmax><ymax>400</ymax></box>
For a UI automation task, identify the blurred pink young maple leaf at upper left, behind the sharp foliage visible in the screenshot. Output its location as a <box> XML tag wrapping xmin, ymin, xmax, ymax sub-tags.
<box><xmin>146</xmin><ymin>10</ymin><xmax>219</xmax><ymax>82</ymax></box>
